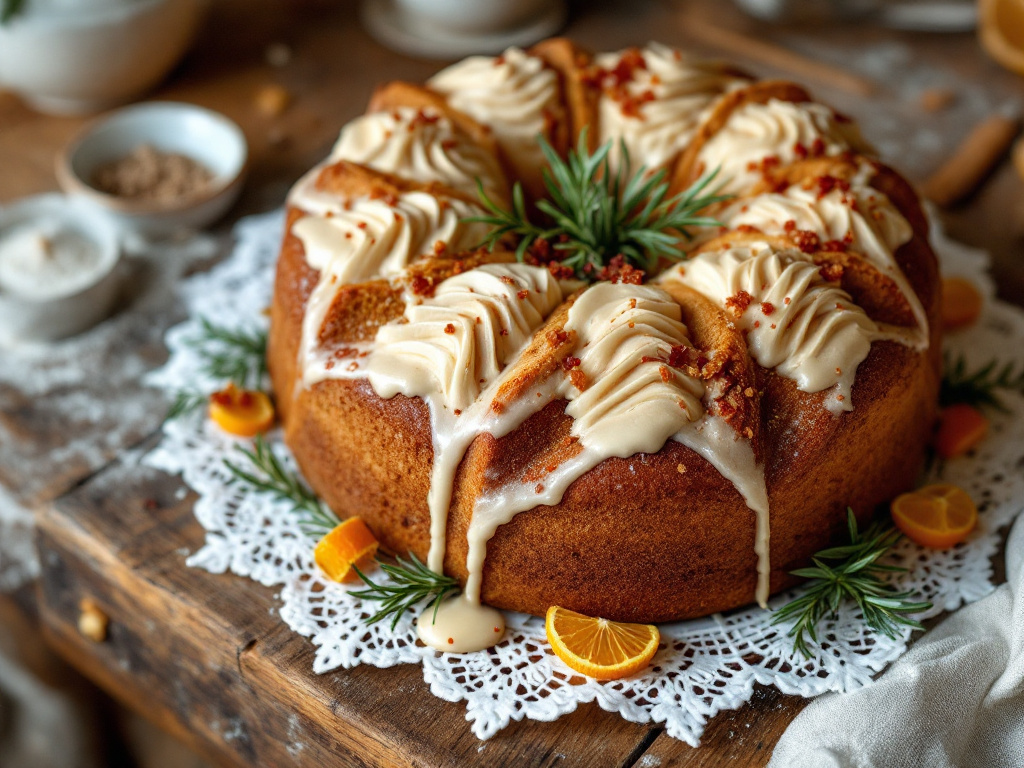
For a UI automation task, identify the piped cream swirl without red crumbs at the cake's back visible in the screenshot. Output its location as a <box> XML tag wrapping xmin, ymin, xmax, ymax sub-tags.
<box><xmin>427</xmin><ymin>48</ymin><xmax>561</xmax><ymax>185</ymax></box>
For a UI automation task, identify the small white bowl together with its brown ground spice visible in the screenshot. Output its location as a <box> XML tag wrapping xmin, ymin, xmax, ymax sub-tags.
<box><xmin>56</xmin><ymin>101</ymin><xmax>248</xmax><ymax>238</ymax></box>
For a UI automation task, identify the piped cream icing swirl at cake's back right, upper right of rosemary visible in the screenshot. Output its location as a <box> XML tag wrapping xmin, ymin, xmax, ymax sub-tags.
<box><xmin>698</xmin><ymin>98</ymin><xmax>867</xmax><ymax>193</ymax></box>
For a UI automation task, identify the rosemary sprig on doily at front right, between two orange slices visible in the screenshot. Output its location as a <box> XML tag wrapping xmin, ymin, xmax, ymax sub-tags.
<box><xmin>771</xmin><ymin>508</ymin><xmax>932</xmax><ymax>658</ymax></box>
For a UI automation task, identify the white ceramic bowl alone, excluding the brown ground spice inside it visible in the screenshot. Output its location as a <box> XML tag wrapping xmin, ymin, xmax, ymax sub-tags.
<box><xmin>56</xmin><ymin>101</ymin><xmax>249</xmax><ymax>238</ymax></box>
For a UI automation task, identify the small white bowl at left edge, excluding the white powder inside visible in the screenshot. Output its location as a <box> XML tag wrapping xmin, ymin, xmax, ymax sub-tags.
<box><xmin>0</xmin><ymin>195</ymin><xmax>121</xmax><ymax>347</ymax></box>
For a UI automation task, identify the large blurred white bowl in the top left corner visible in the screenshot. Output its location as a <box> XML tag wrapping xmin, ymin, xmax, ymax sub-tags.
<box><xmin>0</xmin><ymin>0</ymin><xmax>209</xmax><ymax>114</ymax></box>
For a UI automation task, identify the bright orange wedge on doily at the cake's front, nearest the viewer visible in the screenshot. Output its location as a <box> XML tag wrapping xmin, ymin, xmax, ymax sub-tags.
<box><xmin>544</xmin><ymin>605</ymin><xmax>662</xmax><ymax>680</ymax></box>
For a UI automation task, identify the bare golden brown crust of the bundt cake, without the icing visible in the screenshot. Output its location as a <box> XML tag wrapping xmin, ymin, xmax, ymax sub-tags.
<box><xmin>268</xmin><ymin>39</ymin><xmax>940</xmax><ymax>622</ymax></box>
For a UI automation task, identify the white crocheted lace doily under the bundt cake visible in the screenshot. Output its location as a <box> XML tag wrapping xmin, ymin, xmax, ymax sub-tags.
<box><xmin>146</xmin><ymin>208</ymin><xmax>1024</xmax><ymax>745</ymax></box>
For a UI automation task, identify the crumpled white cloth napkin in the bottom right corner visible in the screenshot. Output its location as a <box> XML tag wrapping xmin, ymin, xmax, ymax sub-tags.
<box><xmin>768</xmin><ymin>516</ymin><xmax>1024</xmax><ymax>768</ymax></box>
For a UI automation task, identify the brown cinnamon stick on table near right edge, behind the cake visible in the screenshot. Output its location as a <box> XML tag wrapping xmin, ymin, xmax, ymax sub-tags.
<box><xmin>921</xmin><ymin>115</ymin><xmax>1020</xmax><ymax>208</ymax></box>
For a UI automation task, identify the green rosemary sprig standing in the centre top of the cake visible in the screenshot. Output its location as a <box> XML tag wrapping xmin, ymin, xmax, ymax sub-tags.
<box><xmin>468</xmin><ymin>129</ymin><xmax>727</xmax><ymax>281</ymax></box>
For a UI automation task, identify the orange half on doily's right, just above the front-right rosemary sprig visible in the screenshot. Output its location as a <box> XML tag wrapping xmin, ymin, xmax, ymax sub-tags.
<box><xmin>892</xmin><ymin>483</ymin><xmax>978</xmax><ymax>549</ymax></box>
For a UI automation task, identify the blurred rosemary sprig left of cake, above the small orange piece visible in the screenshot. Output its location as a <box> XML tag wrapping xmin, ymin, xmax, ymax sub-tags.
<box><xmin>167</xmin><ymin>317</ymin><xmax>266</xmax><ymax>419</ymax></box>
